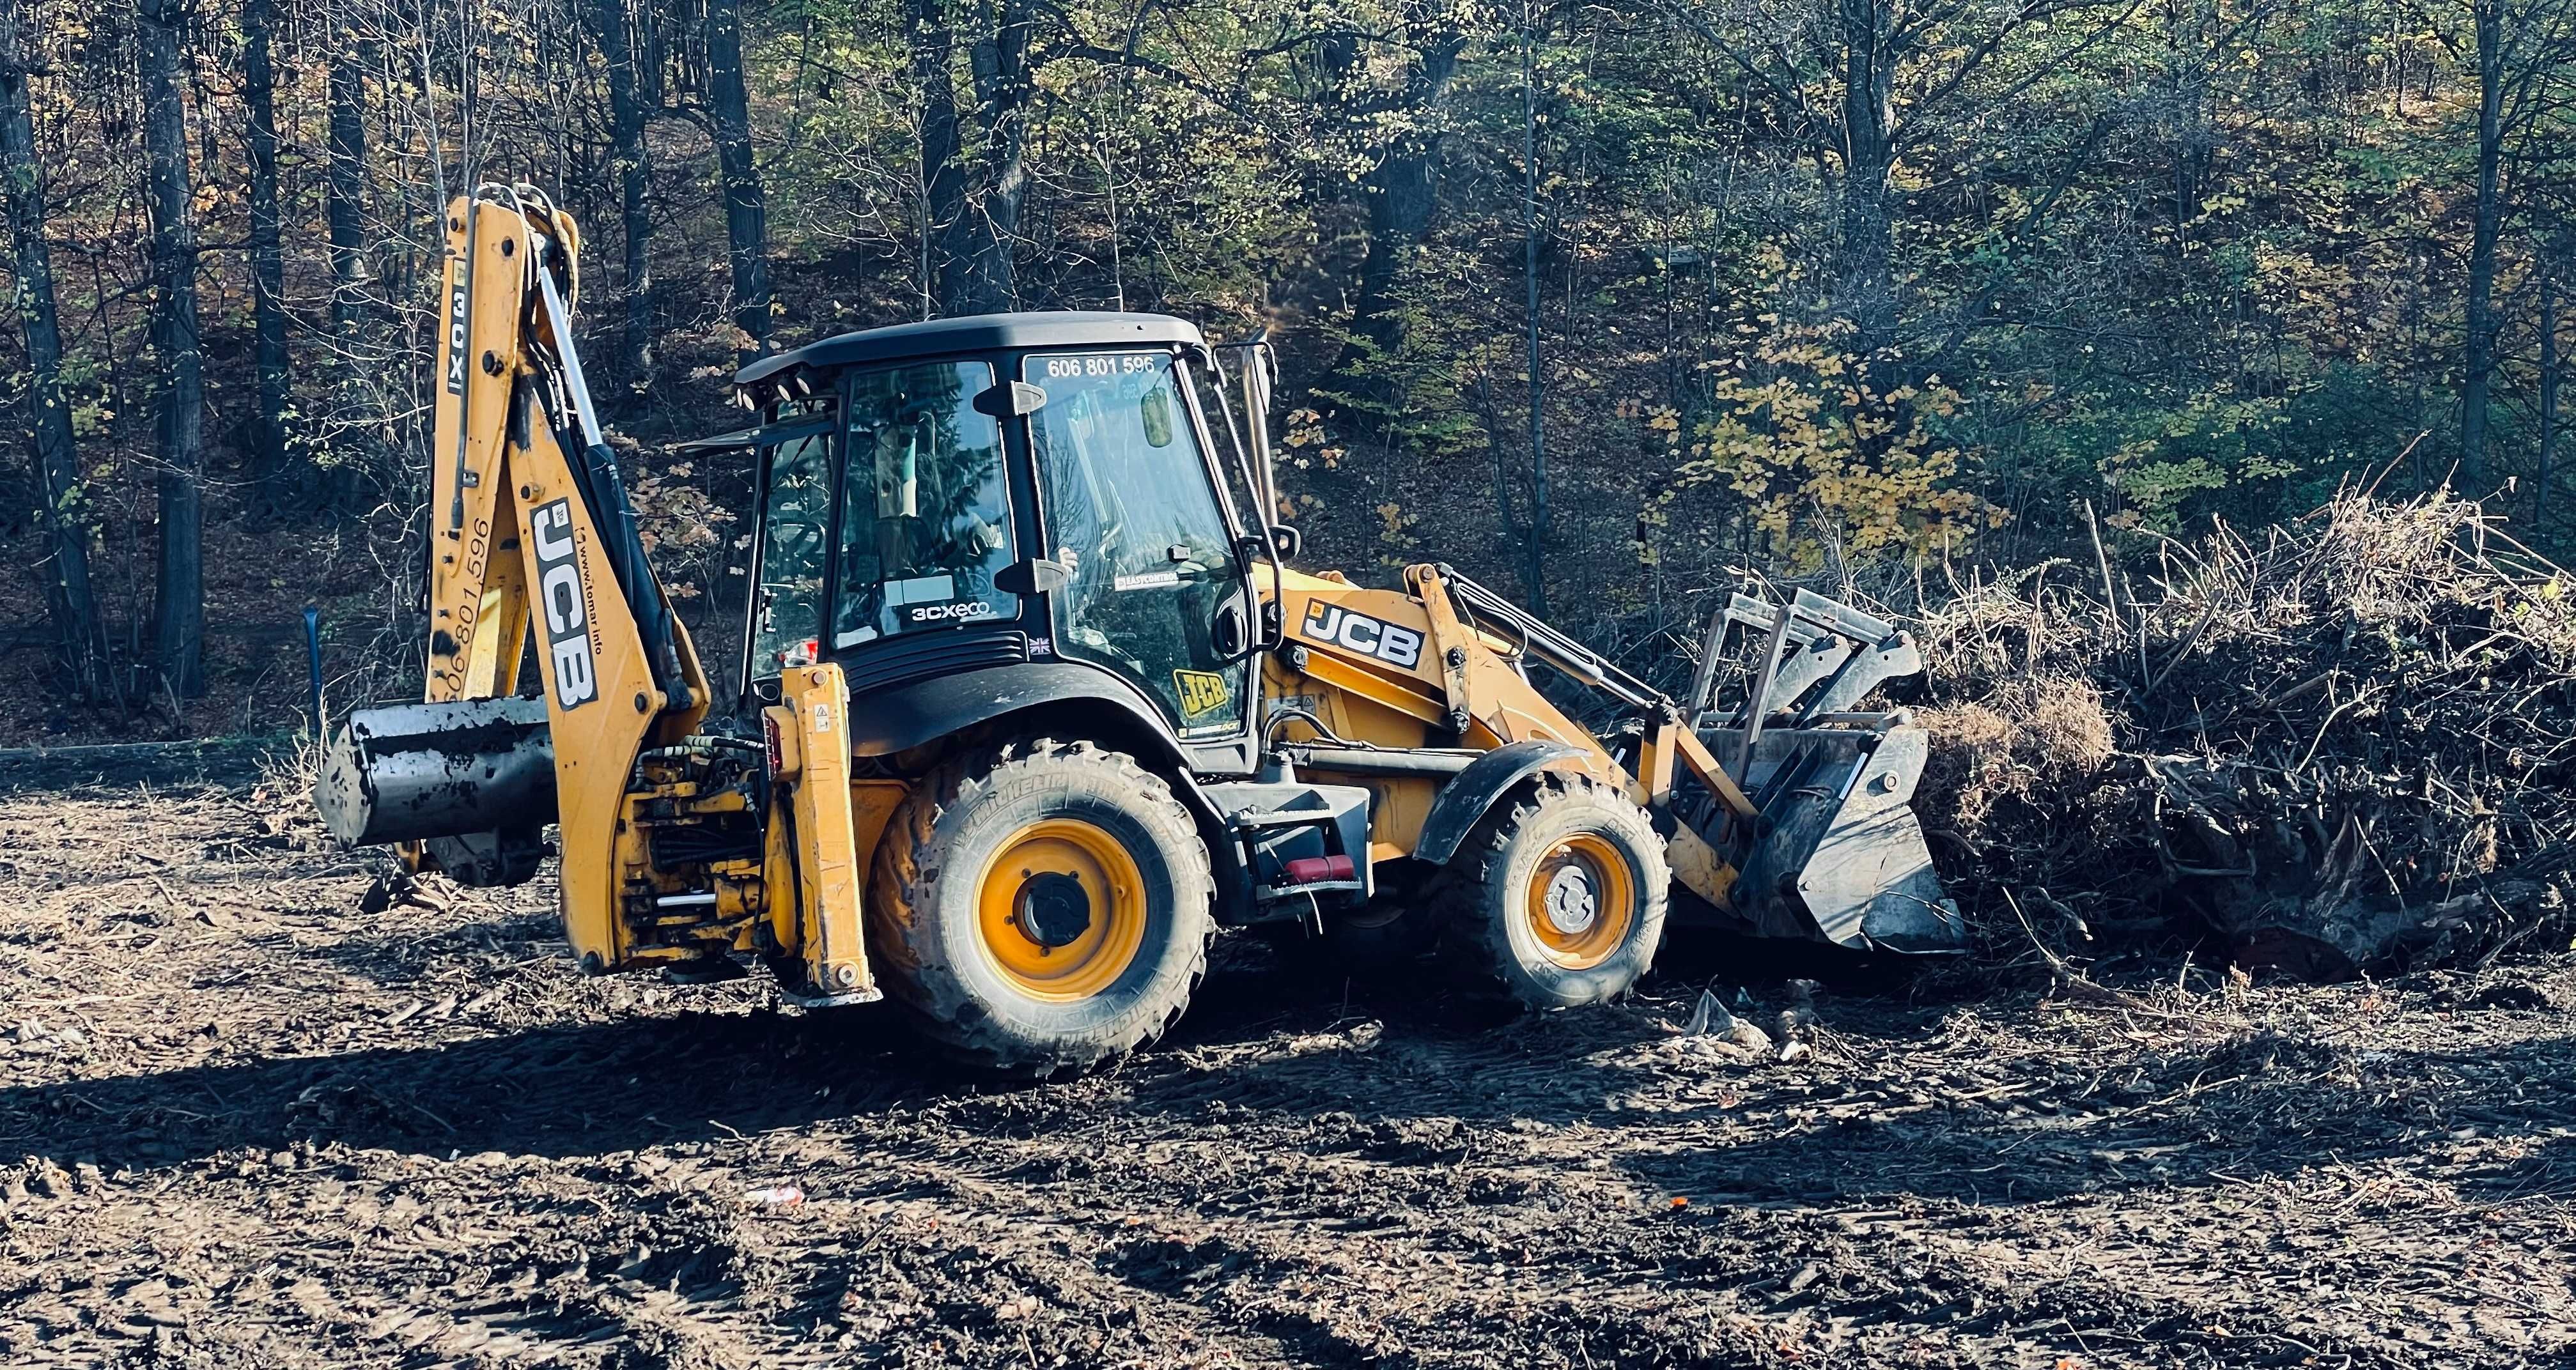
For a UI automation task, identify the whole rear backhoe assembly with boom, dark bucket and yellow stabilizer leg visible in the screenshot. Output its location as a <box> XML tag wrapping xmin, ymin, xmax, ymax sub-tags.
<box><xmin>314</xmin><ymin>185</ymin><xmax>881</xmax><ymax>1004</ymax></box>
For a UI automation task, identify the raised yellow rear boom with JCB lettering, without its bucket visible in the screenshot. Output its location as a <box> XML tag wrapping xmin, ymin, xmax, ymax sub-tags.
<box><xmin>405</xmin><ymin>188</ymin><xmax>708</xmax><ymax>968</ymax></box>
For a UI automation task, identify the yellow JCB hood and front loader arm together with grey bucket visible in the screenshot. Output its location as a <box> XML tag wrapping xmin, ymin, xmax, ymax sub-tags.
<box><xmin>1265</xmin><ymin>564</ymin><xmax>1955</xmax><ymax>950</ymax></box>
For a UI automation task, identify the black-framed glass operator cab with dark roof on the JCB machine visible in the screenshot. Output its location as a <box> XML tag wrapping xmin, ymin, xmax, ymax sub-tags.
<box><xmin>690</xmin><ymin>312</ymin><xmax>1293</xmax><ymax>775</ymax></box>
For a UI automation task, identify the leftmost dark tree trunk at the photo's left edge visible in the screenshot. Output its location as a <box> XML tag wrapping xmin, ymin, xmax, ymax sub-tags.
<box><xmin>0</xmin><ymin>0</ymin><xmax>113</xmax><ymax>700</ymax></box>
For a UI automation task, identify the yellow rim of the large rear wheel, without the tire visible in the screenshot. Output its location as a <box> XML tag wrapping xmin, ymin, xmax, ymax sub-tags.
<box><xmin>976</xmin><ymin>819</ymin><xmax>1144</xmax><ymax>1002</ymax></box>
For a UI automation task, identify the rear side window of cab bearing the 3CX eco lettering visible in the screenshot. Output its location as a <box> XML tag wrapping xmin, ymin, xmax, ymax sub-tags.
<box><xmin>832</xmin><ymin>360</ymin><xmax>1020</xmax><ymax>649</ymax></box>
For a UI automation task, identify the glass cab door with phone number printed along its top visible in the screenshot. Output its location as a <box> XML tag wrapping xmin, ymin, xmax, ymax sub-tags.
<box><xmin>1023</xmin><ymin>350</ymin><xmax>1252</xmax><ymax>770</ymax></box>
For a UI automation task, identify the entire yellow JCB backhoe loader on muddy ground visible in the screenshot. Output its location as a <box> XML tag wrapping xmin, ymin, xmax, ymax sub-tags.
<box><xmin>314</xmin><ymin>185</ymin><xmax>1960</xmax><ymax>1074</ymax></box>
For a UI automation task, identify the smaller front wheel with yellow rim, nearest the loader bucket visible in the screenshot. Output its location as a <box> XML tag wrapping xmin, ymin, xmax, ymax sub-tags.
<box><xmin>1440</xmin><ymin>775</ymin><xmax>1672</xmax><ymax>1010</ymax></box>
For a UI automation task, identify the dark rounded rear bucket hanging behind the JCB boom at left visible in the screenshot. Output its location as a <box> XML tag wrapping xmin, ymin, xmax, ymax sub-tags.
<box><xmin>314</xmin><ymin>698</ymin><xmax>554</xmax><ymax>886</ymax></box>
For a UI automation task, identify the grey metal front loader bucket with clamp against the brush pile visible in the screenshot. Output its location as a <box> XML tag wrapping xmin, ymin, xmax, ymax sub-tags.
<box><xmin>1690</xmin><ymin>590</ymin><xmax>1968</xmax><ymax>953</ymax></box>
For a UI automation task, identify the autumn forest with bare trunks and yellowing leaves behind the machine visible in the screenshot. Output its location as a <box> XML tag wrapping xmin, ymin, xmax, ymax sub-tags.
<box><xmin>0</xmin><ymin>0</ymin><xmax>2576</xmax><ymax>744</ymax></box>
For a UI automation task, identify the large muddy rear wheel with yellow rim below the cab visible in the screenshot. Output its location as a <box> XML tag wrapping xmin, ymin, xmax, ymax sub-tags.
<box><xmin>868</xmin><ymin>739</ymin><xmax>1216</xmax><ymax>1077</ymax></box>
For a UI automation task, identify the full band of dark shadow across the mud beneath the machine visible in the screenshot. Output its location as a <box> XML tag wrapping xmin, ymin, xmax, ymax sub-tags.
<box><xmin>15</xmin><ymin>927</ymin><xmax>2576</xmax><ymax>1226</ymax></box>
